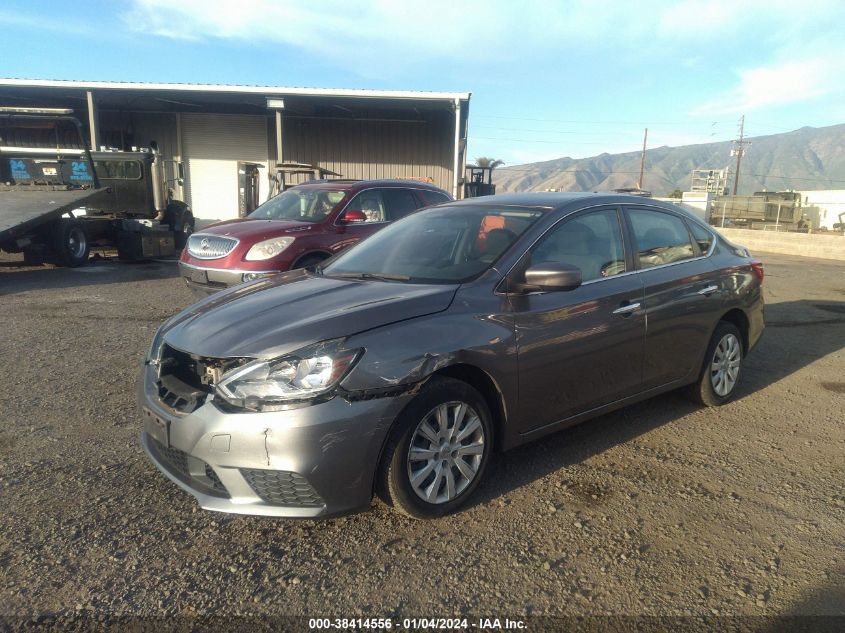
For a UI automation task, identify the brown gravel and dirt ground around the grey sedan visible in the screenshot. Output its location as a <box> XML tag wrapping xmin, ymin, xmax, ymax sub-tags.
<box><xmin>0</xmin><ymin>255</ymin><xmax>845</xmax><ymax>628</ymax></box>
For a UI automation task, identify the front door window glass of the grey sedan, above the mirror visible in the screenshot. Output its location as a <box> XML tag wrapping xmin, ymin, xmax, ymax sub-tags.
<box><xmin>531</xmin><ymin>209</ymin><xmax>625</xmax><ymax>281</ymax></box>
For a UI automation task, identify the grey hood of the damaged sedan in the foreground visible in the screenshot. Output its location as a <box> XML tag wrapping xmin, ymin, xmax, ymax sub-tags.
<box><xmin>164</xmin><ymin>270</ymin><xmax>458</xmax><ymax>359</ymax></box>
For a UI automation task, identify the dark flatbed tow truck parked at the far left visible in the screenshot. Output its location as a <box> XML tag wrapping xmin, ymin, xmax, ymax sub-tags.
<box><xmin>0</xmin><ymin>107</ymin><xmax>194</xmax><ymax>266</ymax></box>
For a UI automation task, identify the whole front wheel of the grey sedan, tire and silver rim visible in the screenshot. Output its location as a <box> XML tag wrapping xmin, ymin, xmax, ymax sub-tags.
<box><xmin>380</xmin><ymin>378</ymin><xmax>493</xmax><ymax>519</ymax></box>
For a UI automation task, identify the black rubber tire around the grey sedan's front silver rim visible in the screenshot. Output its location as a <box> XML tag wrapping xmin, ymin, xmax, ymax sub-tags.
<box><xmin>377</xmin><ymin>377</ymin><xmax>494</xmax><ymax>519</ymax></box>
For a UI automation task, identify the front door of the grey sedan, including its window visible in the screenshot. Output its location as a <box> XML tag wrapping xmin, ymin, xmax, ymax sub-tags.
<box><xmin>512</xmin><ymin>208</ymin><xmax>645</xmax><ymax>433</ymax></box>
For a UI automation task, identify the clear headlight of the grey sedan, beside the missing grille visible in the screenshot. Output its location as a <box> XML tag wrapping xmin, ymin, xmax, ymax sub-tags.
<box><xmin>217</xmin><ymin>340</ymin><xmax>363</xmax><ymax>411</ymax></box>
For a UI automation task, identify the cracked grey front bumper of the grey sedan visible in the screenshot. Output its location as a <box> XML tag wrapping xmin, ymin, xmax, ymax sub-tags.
<box><xmin>139</xmin><ymin>366</ymin><xmax>410</xmax><ymax>518</ymax></box>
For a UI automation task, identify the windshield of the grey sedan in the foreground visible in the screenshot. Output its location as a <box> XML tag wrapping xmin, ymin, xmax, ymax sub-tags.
<box><xmin>322</xmin><ymin>206</ymin><xmax>542</xmax><ymax>283</ymax></box>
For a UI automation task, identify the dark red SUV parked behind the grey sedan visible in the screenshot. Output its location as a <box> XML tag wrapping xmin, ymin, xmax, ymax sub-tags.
<box><xmin>179</xmin><ymin>180</ymin><xmax>452</xmax><ymax>296</ymax></box>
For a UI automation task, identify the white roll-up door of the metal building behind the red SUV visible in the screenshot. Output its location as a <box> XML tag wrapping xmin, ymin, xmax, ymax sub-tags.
<box><xmin>182</xmin><ymin>114</ymin><xmax>268</xmax><ymax>220</ymax></box>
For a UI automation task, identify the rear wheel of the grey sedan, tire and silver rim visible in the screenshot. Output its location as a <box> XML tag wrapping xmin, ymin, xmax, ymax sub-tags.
<box><xmin>688</xmin><ymin>321</ymin><xmax>743</xmax><ymax>407</ymax></box>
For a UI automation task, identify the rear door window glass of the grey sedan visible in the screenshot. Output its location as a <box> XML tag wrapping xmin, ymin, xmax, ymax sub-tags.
<box><xmin>628</xmin><ymin>209</ymin><xmax>696</xmax><ymax>268</ymax></box>
